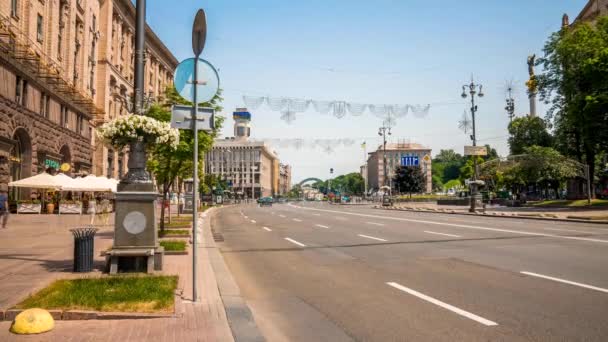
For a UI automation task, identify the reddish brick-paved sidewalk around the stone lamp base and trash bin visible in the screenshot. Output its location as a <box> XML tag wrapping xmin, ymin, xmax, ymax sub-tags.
<box><xmin>0</xmin><ymin>210</ymin><xmax>234</xmax><ymax>342</ymax></box>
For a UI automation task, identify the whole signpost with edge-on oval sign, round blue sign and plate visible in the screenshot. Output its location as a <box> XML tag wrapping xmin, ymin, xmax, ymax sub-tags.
<box><xmin>171</xmin><ymin>9</ymin><xmax>220</xmax><ymax>302</ymax></box>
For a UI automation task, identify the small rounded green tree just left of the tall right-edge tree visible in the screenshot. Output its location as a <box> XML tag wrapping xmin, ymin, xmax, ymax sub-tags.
<box><xmin>509</xmin><ymin>116</ymin><xmax>553</xmax><ymax>154</ymax></box>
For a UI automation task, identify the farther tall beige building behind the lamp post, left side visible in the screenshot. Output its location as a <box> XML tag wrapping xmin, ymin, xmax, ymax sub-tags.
<box><xmin>93</xmin><ymin>0</ymin><xmax>178</xmax><ymax>178</ymax></box>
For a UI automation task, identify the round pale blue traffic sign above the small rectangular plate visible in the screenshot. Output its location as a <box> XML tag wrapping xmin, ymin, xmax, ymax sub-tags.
<box><xmin>173</xmin><ymin>58</ymin><xmax>220</xmax><ymax>103</ymax></box>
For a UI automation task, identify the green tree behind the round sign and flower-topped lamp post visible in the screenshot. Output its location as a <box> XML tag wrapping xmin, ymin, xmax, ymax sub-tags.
<box><xmin>147</xmin><ymin>86</ymin><xmax>223</xmax><ymax>230</ymax></box>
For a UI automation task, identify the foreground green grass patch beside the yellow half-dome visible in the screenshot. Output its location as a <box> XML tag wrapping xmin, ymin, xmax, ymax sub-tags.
<box><xmin>15</xmin><ymin>276</ymin><xmax>177</xmax><ymax>312</ymax></box>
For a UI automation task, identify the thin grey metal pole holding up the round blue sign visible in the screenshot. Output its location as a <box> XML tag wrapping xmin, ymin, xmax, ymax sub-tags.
<box><xmin>192</xmin><ymin>55</ymin><xmax>199</xmax><ymax>302</ymax></box>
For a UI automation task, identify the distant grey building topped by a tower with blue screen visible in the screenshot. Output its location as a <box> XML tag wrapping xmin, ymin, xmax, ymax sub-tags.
<box><xmin>205</xmin><ymin>108</ymin><xmax>280</xmax><ymax>199</ymax></box>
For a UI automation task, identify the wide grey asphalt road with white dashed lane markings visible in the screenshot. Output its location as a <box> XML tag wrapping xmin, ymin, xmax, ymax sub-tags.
<box><xmin>212</xmin><ymin>203</ymin><xmax>608</xmax><ymax>341</ymax></box>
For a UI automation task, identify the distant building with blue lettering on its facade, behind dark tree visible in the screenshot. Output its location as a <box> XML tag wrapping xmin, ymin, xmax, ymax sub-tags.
<box><xmin>367</xmin><ymin>143</ymin><xmax>433</xmax><ymax>193</ymax></box>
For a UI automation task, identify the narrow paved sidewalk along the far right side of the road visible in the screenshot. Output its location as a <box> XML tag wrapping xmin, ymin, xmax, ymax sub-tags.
<box><xmin>394</xmin><ymin>202</ymin><xmax>608</xmax><ymax>221</ymax></box>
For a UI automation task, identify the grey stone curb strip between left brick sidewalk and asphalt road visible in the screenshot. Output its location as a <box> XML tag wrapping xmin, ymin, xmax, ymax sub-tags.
<box><xmin>202</xmin><ymin>207</ymin><xmax>266</xmax><ymax>342</ymax></box>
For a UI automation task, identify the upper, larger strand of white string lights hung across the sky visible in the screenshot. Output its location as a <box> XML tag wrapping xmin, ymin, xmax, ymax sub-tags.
<box><xmin>243</xmin><ymin>95</ymin><xmax>431</xmax><ymax>126</ymax></box>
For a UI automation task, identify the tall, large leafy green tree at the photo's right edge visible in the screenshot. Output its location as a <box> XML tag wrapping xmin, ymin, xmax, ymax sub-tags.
<box><xmin>538</xmin><ymin>16</ymin><xmax>608</xmax><ymax>198</ymax></box>
